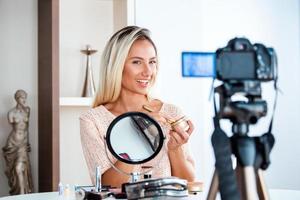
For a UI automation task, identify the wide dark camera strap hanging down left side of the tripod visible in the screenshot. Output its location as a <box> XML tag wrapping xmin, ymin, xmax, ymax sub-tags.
<box><xmin>211</xmin><ymin>94</ymin><xmax>240</xmax><ymax>200</ymax></box>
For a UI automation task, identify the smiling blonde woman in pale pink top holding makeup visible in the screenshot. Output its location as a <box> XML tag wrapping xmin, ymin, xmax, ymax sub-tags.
<box><xmin>80</xmin><ymin>26</ymin><xmax>195</xmax><ymax>187</ymax></box>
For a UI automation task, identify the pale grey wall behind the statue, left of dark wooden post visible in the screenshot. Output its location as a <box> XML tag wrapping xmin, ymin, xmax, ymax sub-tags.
<box><xmin>0</xmin><ymin>0</ymin><xmax>38</xmax><ymax>196</ymax></box>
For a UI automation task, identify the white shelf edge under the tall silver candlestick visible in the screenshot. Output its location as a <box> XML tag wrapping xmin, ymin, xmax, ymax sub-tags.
<box><xmin>59</xmin><ymin>97</ymin><xmax>93</xmax><ymax>107</ymax></box>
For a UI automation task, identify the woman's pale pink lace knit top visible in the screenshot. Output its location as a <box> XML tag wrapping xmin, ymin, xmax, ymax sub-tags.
<box><xmin>80</xmin><ymin>103</ymin><xmax>188</xmax><ymax>184</ymax></box>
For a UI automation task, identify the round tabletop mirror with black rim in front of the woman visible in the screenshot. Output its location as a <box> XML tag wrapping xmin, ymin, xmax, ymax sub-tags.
<box><xmin>106</xmin><ymin>112</ymin><xmax>165</xmax><ymax>164</ymax></box>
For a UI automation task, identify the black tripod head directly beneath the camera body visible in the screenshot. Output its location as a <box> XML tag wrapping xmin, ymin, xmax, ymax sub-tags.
<box><xmin>215</xmin><ymin>81</ymin><xmax>268</xmax><ymax>135</ymax></box>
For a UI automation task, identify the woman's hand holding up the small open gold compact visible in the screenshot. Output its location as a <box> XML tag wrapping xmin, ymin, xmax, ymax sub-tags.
<box><xmin>168</xmin><ymin>120</ymin><xmax>194</xmax><ymax>151</ymax></box>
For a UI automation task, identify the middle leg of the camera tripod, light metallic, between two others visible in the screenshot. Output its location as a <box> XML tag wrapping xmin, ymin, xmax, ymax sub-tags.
<box><xmin>236</xmin><ymin>165</ymin><xmax>258</xmax><ymax>200</ymax></box>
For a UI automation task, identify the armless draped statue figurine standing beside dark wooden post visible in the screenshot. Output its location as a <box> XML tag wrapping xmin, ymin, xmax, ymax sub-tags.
<box><xmin>2</xmin><ymin>90</ymin><xmax>33</xmax><ymax>195</ymax></box>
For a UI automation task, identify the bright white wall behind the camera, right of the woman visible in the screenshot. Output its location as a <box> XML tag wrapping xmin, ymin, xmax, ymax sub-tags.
<box><xmin>136</xmin><ymin>0</ymin><xmax>300</xmax><ymax>189</ymax></box>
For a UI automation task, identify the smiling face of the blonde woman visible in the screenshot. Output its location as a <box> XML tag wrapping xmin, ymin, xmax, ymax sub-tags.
<box><xmin>122</xmin><ymin>40</ymin><xmax>157</xmax><ymax>95</ymax></box>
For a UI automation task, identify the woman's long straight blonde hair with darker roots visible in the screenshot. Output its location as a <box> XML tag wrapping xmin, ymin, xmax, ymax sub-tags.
<box><xmin>93</xmin><ymin>26</ymin><xmax>157</xmax><ymax>108</ymax></box>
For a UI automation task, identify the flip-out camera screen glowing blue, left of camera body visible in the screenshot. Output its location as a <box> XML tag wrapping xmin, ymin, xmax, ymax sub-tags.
<box><xmin>181</xmin><ymin>52</ymin><xmax>216</xmax><ymax>77</ymax></box>
